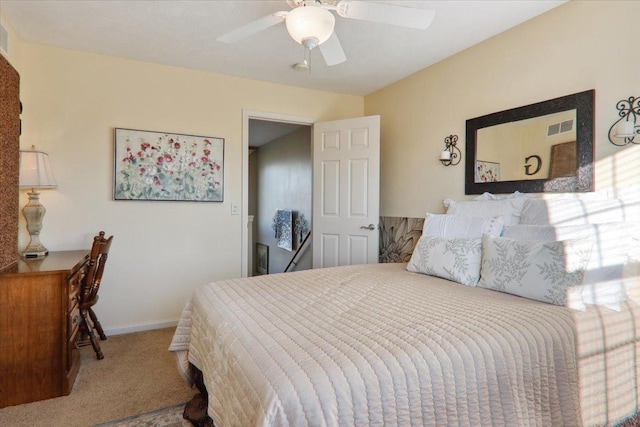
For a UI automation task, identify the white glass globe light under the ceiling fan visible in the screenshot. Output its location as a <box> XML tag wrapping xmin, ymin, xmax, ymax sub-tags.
<box><xmin>286</xmin><ymin>6</ymin><xmax>336</xmax><ymax>45</ymax></box>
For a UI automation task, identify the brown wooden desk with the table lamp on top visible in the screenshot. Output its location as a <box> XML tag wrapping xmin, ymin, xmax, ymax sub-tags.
<box><xmin>0</xmin><ymin>250</ymin><xmax>89</xmax><ymax>408</ymax></box>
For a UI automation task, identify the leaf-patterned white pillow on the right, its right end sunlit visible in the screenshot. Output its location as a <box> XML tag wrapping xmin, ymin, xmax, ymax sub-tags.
<box><xmin>478</xmin><ymin>234</ymin><xmax>592</xmax><ymax>305</ymax></box>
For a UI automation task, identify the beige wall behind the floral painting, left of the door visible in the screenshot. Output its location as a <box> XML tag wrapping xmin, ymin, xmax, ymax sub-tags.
<box><xmin>5</xmin><ymin>35</ymin><xmax>364</xmax><ymax>331</ymax></box>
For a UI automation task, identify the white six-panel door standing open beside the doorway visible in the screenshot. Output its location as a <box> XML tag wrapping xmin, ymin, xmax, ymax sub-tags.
<box><xmin>312</xmin><ymin>116</ymin><xmax>380</xmax><ymax>268</ymax></box>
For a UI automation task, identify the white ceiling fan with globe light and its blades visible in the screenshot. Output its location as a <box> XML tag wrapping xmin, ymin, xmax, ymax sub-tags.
<box><xmin>218</xmin><ymin>0</ymin><xmax>435</xmax><ymax>66</ymax></box>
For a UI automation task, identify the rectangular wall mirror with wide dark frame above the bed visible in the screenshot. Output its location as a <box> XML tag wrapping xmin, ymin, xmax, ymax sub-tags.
<box><xmin>465</xmin><ymin>90</ymin><xmax>595</xmax><ymax>194</ymax></box>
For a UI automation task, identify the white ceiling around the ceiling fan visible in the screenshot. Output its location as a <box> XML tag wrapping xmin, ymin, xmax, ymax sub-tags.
<box><xmin>0</xmin><ymin>0</ymin><xmax>566</xmax><ymax>95</ymax></box>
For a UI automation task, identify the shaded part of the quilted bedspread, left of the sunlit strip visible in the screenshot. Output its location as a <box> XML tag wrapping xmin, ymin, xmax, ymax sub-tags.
<box><xmin>170</xmin><ymin>264</ymin><xmax>580</xmax><ymax>427</ymax></box>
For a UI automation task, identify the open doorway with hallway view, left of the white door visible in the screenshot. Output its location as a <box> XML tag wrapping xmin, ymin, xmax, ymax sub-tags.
<box><xmin>242</xmin><ymin>110</ymin><xmax>314</xmax><ymax>277</ymax></box>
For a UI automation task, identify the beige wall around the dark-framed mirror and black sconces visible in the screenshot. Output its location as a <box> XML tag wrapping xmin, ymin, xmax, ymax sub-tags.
<box><xmin>365</xmin><ymin>0</ymin><xmax>640</xmax><ymax>217</ymax></box>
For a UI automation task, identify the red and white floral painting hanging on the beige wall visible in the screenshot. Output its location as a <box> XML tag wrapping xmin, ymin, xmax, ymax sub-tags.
<box><xmin>113</xmin><ymin>128</ymin><xmax>224</xmax><ymax>202</ymax></box>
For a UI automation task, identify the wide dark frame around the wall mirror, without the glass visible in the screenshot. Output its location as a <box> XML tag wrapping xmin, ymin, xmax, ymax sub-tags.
<box><xmin>465</xmin><ymin>89</ymin><xmax>595</xmax><ymax>194</ymax></box>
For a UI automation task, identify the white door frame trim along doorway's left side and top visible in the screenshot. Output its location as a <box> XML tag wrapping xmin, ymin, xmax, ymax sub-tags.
<box><xmin>240</xmin><ymin>109</ymin><xmax>318</xmax><ymax>277</ymax></box>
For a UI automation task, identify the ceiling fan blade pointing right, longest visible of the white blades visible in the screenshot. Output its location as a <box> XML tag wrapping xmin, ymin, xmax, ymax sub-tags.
<box><xmin>336</xmin><ymin>0</ymin><xmax>436</xmax><ymax>30</ymax></box>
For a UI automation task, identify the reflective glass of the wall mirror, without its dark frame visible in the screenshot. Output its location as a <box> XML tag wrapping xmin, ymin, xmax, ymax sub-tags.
<box><xmin>475</xmin><ymin>109</ymin><xmax>576</xmax><ymax>182</ymax></box>
